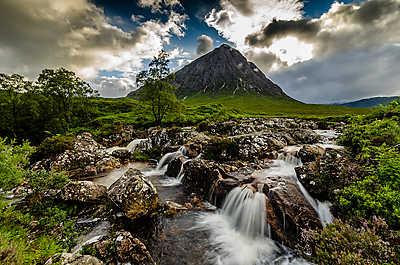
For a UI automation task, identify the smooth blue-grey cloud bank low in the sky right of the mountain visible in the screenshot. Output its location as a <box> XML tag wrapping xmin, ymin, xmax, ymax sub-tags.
<box><xmin>272</xmin><ymin>45</ymin><xmax>400</xmax><ymax>103</ymax></box>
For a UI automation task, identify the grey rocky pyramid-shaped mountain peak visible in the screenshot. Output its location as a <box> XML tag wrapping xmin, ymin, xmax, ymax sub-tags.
<box><xmin>128</xmin><ymin>44</ymin><xmax>289</xmax><ymax>98</ymax></box>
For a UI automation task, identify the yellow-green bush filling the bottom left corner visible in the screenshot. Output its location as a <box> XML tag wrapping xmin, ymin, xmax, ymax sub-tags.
<box><xmin>0</xmin><ymin>198</ymin><xmax>77</xmax><ymax>264</ymax></box>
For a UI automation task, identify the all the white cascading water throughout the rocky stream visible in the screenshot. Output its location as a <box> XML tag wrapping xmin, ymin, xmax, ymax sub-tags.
<box><xmin>93</xmin><ymin>129</ymin><xmax>335</xmax><ymax>265</ymax></box>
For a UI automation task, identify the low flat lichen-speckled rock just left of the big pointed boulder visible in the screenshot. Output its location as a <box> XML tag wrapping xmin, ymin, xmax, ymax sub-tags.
<box><xmin>60</xmin><ymin>181</ymin><xmax>107</xmax><ymax>203</ymax></box>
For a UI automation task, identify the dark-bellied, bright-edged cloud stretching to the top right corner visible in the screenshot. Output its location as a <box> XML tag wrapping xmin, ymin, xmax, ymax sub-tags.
<box><xmin>246</xmin><ymin>0</ymin><xmax>400</xmax><ymax>66</ymax></box>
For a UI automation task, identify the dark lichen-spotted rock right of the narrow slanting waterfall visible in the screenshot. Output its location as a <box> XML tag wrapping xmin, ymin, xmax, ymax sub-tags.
<box><xmin>295</xmin><ymin>148</ymin><xmax>363</xmax><ymax>201</ymax></box>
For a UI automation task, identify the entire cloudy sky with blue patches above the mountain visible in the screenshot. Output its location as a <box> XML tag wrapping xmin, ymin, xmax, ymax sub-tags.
<box><xmin>0</xmin><ymin>0</ymin><xmax>400</xmax><ymax>103</ymax></box>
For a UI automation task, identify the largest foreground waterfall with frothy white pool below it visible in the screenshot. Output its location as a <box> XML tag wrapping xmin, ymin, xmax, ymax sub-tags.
<box><xmin>196</xmin><ymin>187</ymin><xmax>308</xmax><ymax>265</ymax></box>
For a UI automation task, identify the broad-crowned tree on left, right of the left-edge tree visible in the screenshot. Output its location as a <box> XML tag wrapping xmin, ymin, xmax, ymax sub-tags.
<box><xmin>37</xmin><ymin>68</ymin><xmax>97</xmax><ymax>132</ymax></box>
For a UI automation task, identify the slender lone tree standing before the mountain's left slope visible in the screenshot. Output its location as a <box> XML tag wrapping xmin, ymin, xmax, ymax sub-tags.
<box><xmin>136</xmin><ymin>50</ymin><xmax>179</xmax><ymax>125</ymax></box>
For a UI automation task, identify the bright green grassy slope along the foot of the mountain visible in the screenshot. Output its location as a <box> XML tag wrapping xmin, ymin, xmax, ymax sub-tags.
<box><xmin>83</xmin><ymin>95</ymin><xmax>370</xmax><ymax>135</ymax></box>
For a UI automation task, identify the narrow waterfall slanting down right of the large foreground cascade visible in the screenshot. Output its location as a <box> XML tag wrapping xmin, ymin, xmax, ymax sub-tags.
<box><xmin>274</xmin><ymin>154</ymin><xmax>333</xmax><ymax>226</ymax></box>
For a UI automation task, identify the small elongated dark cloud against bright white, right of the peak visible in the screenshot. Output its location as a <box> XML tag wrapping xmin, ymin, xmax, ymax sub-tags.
<box><xmin>246</xmin><ymin>19</ymin><xmax>320</xmax><ymax>46</ymax></box>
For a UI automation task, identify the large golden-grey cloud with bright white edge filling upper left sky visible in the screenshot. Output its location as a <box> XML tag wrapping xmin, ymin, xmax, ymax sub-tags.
<box><xmin>0</xmin><ymin>0</ymin><xmax>187</xmax><ymax>96</ymax></box>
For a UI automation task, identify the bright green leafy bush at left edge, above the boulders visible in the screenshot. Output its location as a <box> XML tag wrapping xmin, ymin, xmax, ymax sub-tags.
<box><xmin>0</xmin><ymin>138</ymin><xmax>34</xmax><ymax>190</ymax></box>
